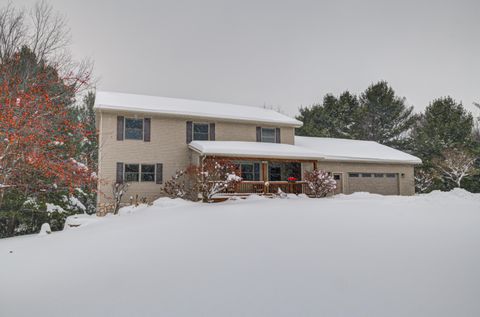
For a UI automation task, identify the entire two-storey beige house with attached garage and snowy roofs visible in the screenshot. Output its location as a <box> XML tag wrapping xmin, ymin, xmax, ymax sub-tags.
<box><xmin>94</xmin><ymin>91</ymin><xmax>421</xmax><ymax>203</ymax></box>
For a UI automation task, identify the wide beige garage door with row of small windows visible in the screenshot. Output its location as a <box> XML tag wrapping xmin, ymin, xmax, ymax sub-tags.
<box><xmin>346</xmin><ymin>173</ymin><xmax>400</xmax><ymax>195</ymax></box>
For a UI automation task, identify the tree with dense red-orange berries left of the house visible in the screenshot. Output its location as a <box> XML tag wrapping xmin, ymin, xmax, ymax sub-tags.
<box><xmin>0</xmin><ymin>47</ymin><xmax>94</xmax><ymax>207</ymax></box>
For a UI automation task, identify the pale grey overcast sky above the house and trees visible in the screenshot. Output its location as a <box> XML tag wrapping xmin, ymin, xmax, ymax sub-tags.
<box><xmin>13</xmin><ymin>0</ymin><xmax>480</xmax><ymax>115</ymax></box>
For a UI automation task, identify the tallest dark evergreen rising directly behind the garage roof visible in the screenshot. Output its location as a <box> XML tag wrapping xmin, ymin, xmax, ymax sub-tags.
<box><xmin>357</xmin><ymin>81</ymin><xmax>415</xmax><ymax>148</ymax></box>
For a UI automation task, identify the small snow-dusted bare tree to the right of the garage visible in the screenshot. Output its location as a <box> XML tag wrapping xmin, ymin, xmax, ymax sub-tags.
<box><xmin>433</xmin><ymin>149</ymin><xmax>476</xmax><ymax>187</ymax></box>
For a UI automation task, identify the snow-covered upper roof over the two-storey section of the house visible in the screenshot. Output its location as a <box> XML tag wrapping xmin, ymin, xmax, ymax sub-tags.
<box><xmin>94</xmin><ymin>91</ymin><xmax>302</xmax><ymax>127</ymax></box>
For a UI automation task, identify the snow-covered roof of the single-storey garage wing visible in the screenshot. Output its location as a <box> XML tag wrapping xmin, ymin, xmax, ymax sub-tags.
<box><xmin>295</xmin><ymin>136</ymin><xmax>422</xmax><ymax>164</ymax></box>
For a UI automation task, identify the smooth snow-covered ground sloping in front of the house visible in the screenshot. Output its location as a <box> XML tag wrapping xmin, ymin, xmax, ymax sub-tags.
<box><xmin>0</xmin><ymin>191</ymin><xmax>480</xmax><ymax>317</ymax></box>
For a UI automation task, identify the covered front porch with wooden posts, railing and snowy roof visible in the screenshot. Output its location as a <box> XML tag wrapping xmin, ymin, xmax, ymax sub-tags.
<box><xmin>190</xmin><ymin>141</ymin><xmax>319</xmax><ymax>196</ymax></box>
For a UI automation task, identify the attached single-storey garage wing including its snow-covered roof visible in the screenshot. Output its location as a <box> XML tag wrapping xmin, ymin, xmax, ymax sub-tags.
<box><xmin>295</xmin><ymin>136</ymin><xmax>422</xmax><ymax>195</ymax></box>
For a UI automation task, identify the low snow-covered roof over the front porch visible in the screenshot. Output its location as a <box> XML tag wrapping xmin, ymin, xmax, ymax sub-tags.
<box><xmin>189</xmin><ymin>141</ymin><xmax>321</xmax><ymax>160</ymax></box>
